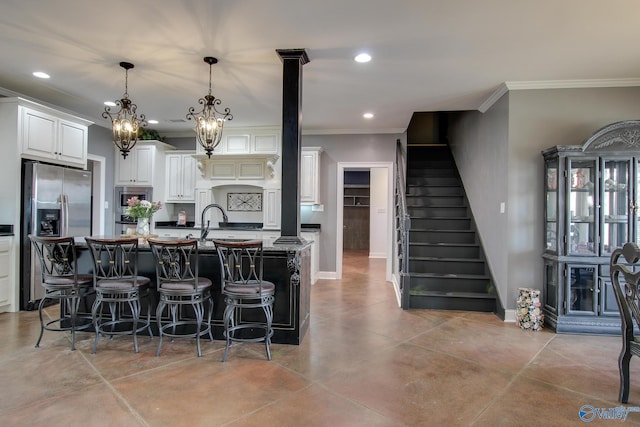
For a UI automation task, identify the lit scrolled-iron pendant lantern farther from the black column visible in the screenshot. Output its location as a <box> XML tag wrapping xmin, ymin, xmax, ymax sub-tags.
<box><xmin>102</xmin><ymin>62</ymin><xmax>147</xmax><ymax>159</ymax></box>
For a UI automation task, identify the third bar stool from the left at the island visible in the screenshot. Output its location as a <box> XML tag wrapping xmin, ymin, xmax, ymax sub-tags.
<box><xmin>147</xmin><ymin>238</ymin><xmax>213</xmax><ymax>357</ymax></box>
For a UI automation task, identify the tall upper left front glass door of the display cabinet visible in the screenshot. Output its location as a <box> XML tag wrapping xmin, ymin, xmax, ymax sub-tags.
<box><xmin>567</xmin><ymin>159</ymin><xmax>598</xmax><ymax>255</ymax></box>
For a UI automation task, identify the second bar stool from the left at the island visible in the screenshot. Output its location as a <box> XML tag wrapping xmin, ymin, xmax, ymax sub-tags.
<box><xmin>85</xmin><ymin>237</ymin><xmax>153</xmax><ymax>353</ymax></box>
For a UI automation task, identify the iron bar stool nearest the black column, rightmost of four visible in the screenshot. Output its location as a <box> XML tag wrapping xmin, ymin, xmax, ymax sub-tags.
<box><xmin>213</xmin><ymin>240</ymin><xmax>276</xmax><ymax>362</ymax></box>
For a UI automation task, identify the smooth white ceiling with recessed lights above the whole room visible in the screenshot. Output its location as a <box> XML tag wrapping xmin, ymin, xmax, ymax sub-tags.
<box><xmin>0</xmin><ymin>0</ymin><xmax>640</xmax><ymax>135</ymax></box>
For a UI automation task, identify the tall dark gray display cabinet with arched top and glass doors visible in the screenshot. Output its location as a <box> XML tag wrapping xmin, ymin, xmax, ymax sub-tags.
<box><xmin>542</xmin><ymin>120</ymin><xmax>640</xmax><ymax>334</ymax></box>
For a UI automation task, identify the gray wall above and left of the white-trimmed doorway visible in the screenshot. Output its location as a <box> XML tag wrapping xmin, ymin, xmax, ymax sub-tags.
<box><xmin>300</xmin><ymin>134</ymin><xmax>405</xmax><ymax>272</ymax></box>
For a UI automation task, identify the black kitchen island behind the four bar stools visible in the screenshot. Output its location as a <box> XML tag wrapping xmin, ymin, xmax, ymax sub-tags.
<box><xmin>76</xmin><ymin>238</ymin><xmax>311</xmax><ymax>344</ymax></box>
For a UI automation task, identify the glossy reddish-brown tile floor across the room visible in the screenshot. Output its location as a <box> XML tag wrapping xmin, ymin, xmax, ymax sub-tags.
<box><xmin>0</xmin><ymin>251</ymin><xmax>640</xmax><ymax>427</ymax></box>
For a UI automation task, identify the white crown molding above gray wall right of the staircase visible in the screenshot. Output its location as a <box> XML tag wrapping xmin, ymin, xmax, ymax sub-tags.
<box><xmin>478</xmin><ymin>77</ymin><xmax>640</xmax><ymax>113</ymax></box>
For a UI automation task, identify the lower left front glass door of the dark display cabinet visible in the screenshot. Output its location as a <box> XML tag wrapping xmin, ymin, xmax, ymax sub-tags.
<box><xmin>566</xmin><ymin>265</ymin><xmax>598</xmax><ymax>315</ymax></box>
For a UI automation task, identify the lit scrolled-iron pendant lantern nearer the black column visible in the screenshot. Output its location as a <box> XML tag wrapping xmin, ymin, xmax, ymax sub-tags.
<box><xmin>187</xmin><ymin>56</ymin><xmax>233</xmax><ymax>158</ymax></box>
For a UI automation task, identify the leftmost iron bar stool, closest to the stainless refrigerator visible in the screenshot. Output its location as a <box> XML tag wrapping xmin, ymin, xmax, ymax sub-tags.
<box><xmin>29</xmin><ymin>235</ymin><xmax>94</xmax><ymax>350</ymax></box>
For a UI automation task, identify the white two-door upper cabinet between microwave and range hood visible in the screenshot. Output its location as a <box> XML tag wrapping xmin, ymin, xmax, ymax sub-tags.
<box><xmin>165</xmin><ymin>151</ymin><xmax>196</xmax><ymax>202</ymax></box>
